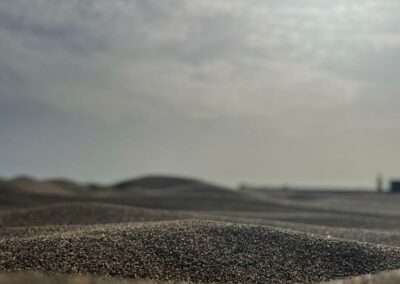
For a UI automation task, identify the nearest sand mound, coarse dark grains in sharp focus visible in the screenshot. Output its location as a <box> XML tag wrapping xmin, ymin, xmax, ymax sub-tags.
<box><xmin>0</xmin><ymin>220</ymin><xmax>400</xmax><ymax>283</ymax></box>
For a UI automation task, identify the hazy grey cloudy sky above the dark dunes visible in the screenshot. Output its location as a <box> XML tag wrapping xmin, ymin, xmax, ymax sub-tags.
<box><xmin>0</xmin><ymin>0</ymin><xmax>400</xmax><ymax>187</ymax></box>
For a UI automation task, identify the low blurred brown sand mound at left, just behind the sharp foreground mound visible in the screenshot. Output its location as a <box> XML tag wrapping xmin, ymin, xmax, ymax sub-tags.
<box><xmin>0</xmin><ymin>203</ymin><xmax>195</xmax><ymax>228</ymax></box>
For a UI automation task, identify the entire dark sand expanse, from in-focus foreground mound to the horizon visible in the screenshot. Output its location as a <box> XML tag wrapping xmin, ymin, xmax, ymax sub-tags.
<box><xmin>0</xmin><ymin>177</ymin><xmax>400</xmax><ymax>283</ymax></box>
